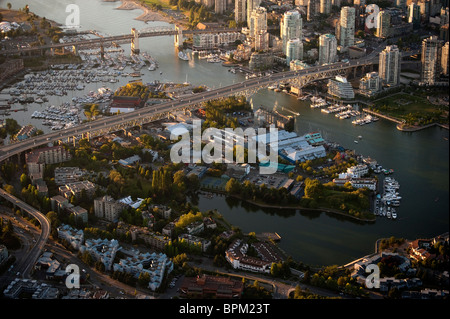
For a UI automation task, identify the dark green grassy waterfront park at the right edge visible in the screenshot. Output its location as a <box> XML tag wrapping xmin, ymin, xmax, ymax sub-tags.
<box><xmin>371</xmin><ymin>93</ymin><xmax>448</xmax><ymax>125</ymax></box>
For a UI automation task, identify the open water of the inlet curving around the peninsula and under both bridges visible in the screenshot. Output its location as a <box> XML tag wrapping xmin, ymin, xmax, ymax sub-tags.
<box><xmin>0</xmin><ymin>0</ymin><xmax>449</xmax><ymax>265</ymax></box>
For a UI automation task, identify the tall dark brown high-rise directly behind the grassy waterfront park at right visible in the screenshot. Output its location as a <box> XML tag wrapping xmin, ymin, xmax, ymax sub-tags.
<box><xmin>421</xmin><ymin>36</ymin><xmax>442</xmax><ymax>85</ymax></box>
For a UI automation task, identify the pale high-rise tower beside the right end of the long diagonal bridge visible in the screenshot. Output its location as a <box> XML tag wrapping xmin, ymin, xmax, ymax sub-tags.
<box><xmin>378</xmin><ymin>45</ymin><xmax>401</xmax><ymax>86</ymax></box>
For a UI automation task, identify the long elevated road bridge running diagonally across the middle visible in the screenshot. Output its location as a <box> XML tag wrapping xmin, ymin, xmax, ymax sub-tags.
<box><xmin>0</xmin><ymin>49</ymin><xmax>419</xmax><ymax>162</ymax></box>
